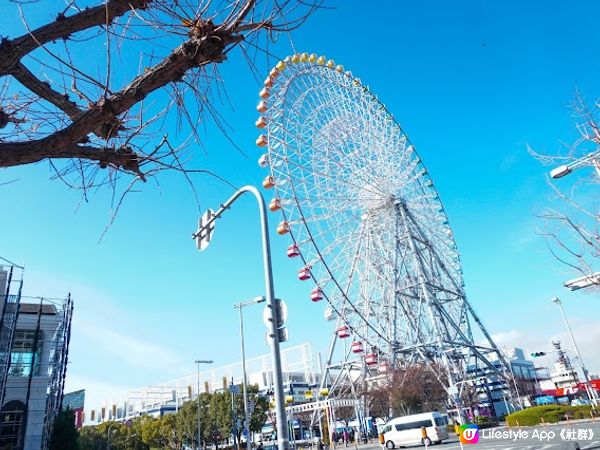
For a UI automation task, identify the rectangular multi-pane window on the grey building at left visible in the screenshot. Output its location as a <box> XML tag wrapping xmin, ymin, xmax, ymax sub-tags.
<box><xmin>8</xmin><ymin>330</ymin><xmax>44</xmax><ymax>377</ymax></box>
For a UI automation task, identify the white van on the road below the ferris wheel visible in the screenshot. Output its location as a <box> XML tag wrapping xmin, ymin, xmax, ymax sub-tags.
<box><xmin>379</xmin><ymin>411</ymin><xmax>448</xmax><ymax>449</ymax></box>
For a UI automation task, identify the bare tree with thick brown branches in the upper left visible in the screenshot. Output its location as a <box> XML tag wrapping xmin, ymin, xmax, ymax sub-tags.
<box><xmin>0</xmin><ymin>0</ymin><xmax>316</xmax><ymax>197</ymax></box>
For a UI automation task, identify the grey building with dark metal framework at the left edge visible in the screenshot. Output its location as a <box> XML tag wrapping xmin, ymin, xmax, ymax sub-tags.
<box><xmin>0</xmin><ymin>260</ymin><xmax>73</xmax><ymax>450</ymax></box>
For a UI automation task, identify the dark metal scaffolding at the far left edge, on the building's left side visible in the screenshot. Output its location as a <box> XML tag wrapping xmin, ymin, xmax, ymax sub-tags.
<box><xmin>0</xmin><ymin>257</ymin><xmax>23</xmax><ymax>406</ymax></box>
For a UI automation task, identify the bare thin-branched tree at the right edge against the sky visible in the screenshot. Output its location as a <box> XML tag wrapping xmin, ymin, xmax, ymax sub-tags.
<box><xmin>529</xmin><ymin>92</ymin><xmax>600</xmax><ymax>290</ymax></box>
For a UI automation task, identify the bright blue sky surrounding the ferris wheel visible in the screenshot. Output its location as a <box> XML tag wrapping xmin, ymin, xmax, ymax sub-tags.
<box><xmin>0</xmin><ymin>0</ymin><xmax>600</xmax><ymax>408</ymax></box>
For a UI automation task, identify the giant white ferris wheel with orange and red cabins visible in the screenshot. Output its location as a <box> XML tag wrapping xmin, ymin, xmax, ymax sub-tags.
<box><xmin>256</xmin><ymin>53</ymin><xmax>512</xmax><ymax>400</ymax></box>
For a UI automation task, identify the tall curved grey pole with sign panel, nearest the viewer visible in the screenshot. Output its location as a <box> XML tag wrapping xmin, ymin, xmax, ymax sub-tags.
<box><xmin>192</xmin><ymin>186</ymin><xmax>289</xmax><ymax>450</ymax></box>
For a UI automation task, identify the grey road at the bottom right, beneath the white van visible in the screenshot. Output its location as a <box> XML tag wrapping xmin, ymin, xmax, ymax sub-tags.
<box><xmin>350</xmin><ymin>421</ymin><xmax>600</xmax><ymax>450</ymax></box>
